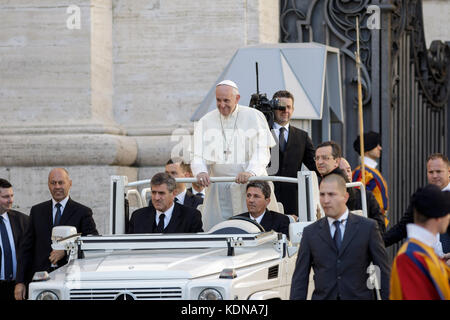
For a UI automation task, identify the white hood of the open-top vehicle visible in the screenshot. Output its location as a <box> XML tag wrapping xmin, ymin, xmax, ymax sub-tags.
<box><xmin>60</xmin><ymin>246</ymin><xmax>280</xmax><ymax>281</ymax></box>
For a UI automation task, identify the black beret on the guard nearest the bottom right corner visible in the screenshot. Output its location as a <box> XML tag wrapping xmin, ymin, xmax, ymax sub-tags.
<box><xmin>411</xmin><ymin>184</ymin><xmax>450</xmax><ymax>218</ymax></box>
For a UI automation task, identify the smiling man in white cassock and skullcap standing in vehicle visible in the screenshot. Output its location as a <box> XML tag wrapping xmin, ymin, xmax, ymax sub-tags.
<box><xmin>191</xmin><ymin>80</ymin><xmax>278</xmax><ymax>231</ymax></box>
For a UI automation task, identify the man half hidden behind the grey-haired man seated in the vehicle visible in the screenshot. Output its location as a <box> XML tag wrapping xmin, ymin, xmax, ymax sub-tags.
<box><xmin>166</xmin><ymin>159</ymin><xmax>203</xmax><ymax>209</ymax></box>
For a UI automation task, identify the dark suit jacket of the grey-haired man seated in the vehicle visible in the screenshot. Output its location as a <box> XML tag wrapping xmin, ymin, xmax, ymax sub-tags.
<box><xmin>127</xmin><ymin>203</ymin><xmax>203</xmax><ymax>233</ymax></box>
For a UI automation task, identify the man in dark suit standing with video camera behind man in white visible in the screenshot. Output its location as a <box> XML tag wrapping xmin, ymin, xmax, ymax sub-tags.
<box><xmin>270</xmin><ymin>90</ymin><xmax>316</xmax><ymax>216</ymax></box>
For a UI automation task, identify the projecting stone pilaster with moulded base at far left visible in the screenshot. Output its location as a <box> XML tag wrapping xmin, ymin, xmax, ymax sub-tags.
<box><xmin>0</xmin><ymin>0</ymin><xmax>137</xmax><ymax>233</ymax></box>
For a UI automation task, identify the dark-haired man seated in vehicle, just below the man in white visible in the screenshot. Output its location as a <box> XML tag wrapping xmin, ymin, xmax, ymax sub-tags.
<box><xmin>239</xmin><ymin>181</ymin><xmax>289</xmax><ymax>237</ymax></box>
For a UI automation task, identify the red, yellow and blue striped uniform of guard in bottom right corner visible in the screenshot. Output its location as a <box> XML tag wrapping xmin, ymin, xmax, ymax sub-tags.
<box><xmin>389</xmin><ymin>239</ymin><xmax>450</xmax><ymax>300</ymax></box>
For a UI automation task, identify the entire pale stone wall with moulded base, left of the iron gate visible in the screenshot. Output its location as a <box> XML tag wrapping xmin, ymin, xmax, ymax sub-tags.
<box><xmin>0</xmin><ymin>0</ymin><xmax>279</xmax><ymax>233</ymax></box>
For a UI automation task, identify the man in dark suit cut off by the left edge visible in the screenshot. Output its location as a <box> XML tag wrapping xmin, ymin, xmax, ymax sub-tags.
<box><xmin>0</xmin><ymin>179</ymin><xmax>29</xmax><ymax>300</ymax></box>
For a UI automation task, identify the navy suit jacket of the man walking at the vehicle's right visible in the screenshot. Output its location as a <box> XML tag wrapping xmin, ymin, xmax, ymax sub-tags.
<box><xmin>291</xmin><ymin>213</ymin><xmax>390</xmax><ymax>300</ymax></box>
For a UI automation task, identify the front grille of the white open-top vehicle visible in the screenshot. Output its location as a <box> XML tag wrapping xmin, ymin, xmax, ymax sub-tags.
<box><xmin>70</xmin><ymin>287</ymin><xmax>183</xmax><ymax>300</ymax></box>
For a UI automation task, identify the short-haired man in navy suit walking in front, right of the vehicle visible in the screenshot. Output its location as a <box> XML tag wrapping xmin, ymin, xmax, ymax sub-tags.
<box><xmin>290</xmin><ymin>174</ymin><xmax>390</xmax><ymax>300</ymax></box>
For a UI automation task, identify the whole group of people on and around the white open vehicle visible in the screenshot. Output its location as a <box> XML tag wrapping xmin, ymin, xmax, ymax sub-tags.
<box><xmin>0</xmin><ymin>80</ymin><xmax>450</xmax><ymax>300</ymax></box>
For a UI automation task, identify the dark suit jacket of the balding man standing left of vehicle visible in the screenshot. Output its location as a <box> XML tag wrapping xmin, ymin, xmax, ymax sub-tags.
<box><xmin>16</xmin><ymin>198</ymin><xmax>98</xmax><ymax>283</ymax></box>
